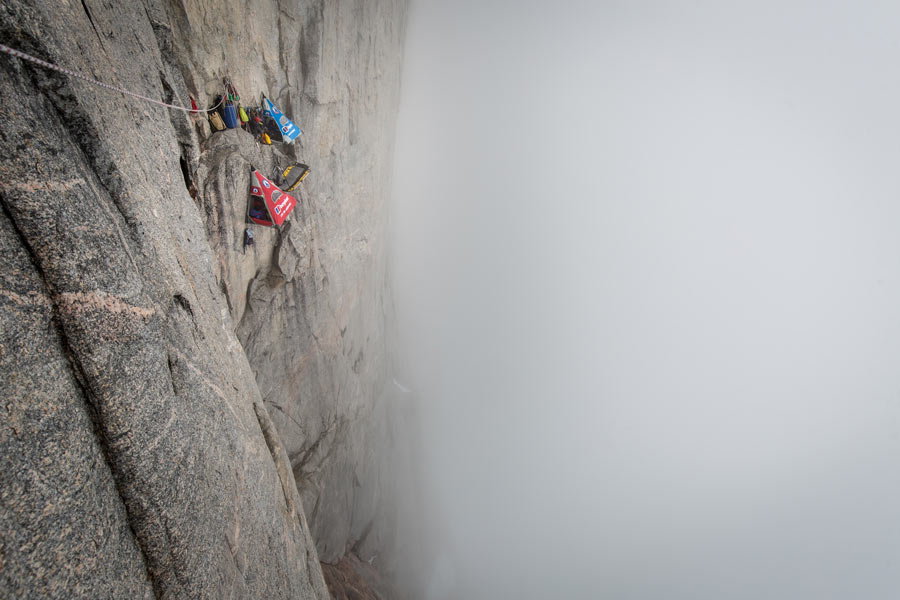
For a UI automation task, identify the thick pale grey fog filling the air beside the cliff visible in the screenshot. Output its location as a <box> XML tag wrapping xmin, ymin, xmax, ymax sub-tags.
<box><xmin>392</xmin><ymin>0</ymin><xmax>900</xmax><ymax>600</ymax></box>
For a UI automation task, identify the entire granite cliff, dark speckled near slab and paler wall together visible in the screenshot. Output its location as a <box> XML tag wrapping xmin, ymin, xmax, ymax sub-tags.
<box><xmin>0</xmin><ymin>0</ymin><xmax>406</xmax><ymax>598</ymax></box>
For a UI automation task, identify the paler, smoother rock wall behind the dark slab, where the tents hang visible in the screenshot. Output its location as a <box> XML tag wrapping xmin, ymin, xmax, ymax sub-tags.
<box><xmin>162</xmin><ymin>0</ymin><xmax>406</xmax><ymax>561</ymax></box>
